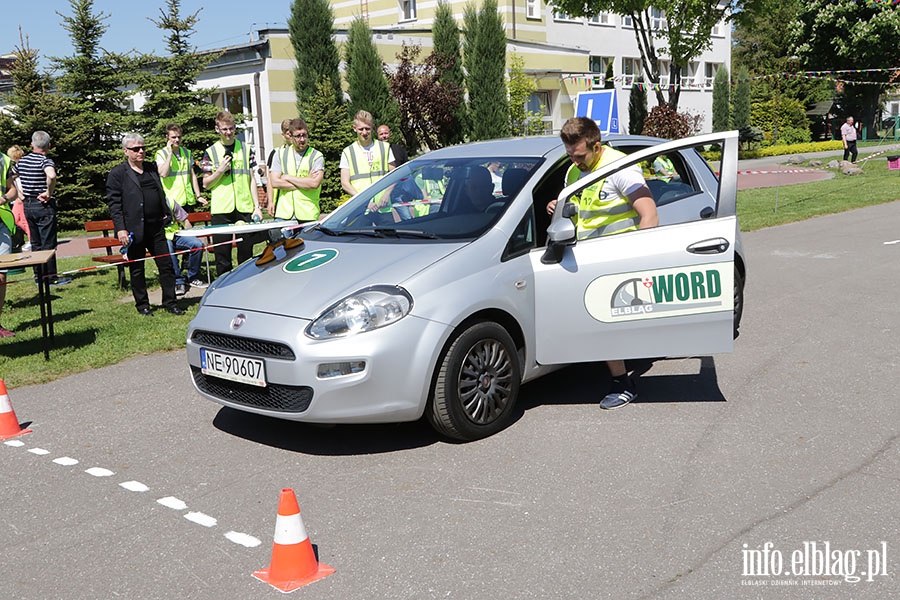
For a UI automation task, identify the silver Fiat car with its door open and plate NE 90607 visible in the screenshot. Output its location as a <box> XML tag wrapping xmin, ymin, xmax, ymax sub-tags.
<box><xmin>187</xmin><ymin>132</ymin><xmax>746</xmax><ymax>440</ymax></box>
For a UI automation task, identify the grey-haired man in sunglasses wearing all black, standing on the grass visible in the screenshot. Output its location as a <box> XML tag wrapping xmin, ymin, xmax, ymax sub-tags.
<box><xmin>106</xmin><ymin>133</ymin><xmax>187</xmax><ymax>317</ymax></box>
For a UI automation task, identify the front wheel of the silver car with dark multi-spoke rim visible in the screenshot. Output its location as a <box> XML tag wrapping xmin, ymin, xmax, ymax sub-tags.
<box><xmin>426</xmin><ymin>322</ymin><xmax>522</xmax><ymax>441</ymax></box>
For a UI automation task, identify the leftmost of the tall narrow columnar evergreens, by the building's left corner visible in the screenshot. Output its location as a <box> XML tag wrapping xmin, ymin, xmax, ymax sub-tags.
<box><xmin>288</xmin><ymin>0</ymin><xmax>344</xmax><ymax>106</ymax></box>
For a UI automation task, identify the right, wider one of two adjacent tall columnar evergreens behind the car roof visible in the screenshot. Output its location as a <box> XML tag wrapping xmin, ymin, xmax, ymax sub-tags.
<box><xmin>466</xmin><ymin>0</ymin><xmax>509</xmax><ymax>140</ymax></box>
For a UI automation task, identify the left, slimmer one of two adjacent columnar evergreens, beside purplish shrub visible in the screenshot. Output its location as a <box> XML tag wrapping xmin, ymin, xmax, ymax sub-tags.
<box><xmin>432</xmin><ymin>0</ymin><xmax>466</xmax><ymax>146</ymax></box>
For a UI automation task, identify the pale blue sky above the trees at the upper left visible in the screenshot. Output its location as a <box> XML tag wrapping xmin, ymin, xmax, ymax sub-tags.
<box><xmin>7</xmin><ymin>0</ymin><xmax>291</xmax><ymax>68</ymax></box>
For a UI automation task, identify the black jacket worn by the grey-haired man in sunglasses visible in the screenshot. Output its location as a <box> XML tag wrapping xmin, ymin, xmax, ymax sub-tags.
<box><xmin>106</xmin><ymin>160</ymin><xmax>172</xmax><ymax>242</ymax></box>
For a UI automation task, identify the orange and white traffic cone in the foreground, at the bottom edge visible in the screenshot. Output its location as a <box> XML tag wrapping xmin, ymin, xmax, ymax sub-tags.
<box><xmin>253</xmin><ymin>488</ymin><xmax>334</xmax><ymax>592</ymax></box>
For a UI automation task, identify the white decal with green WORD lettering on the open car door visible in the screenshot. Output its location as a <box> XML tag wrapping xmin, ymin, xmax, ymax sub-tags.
<box><xmin>584</xmin><ymin>263</ymin><xmax>734</xmax><ymax>323</ymax></box>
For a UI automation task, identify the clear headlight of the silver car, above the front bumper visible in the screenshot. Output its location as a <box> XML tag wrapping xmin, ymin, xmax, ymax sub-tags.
<box><xmin>306</xmin><ymin>285</ymin><xmax>412</xmax><ymax>340</ymax></box>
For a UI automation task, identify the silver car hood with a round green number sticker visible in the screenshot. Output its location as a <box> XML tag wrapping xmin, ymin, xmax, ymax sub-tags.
<box><xmin>203</xmin><ymin>239</ymin><xmax>468</xmax><ymax>319</ymax></box>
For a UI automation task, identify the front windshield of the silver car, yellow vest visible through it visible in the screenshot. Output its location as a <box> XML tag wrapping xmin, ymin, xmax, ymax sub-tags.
<box><xmin>317</xmin><ymin>157</ymin><xmax>543</xmax><ymax>239</ymax></box>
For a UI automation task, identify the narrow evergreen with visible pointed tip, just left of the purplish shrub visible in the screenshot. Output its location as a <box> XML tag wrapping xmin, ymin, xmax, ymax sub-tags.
<box><xmin>344</xmin><ymin>16</ymin><xmax>399</xmax><ymax>129</ymax></box>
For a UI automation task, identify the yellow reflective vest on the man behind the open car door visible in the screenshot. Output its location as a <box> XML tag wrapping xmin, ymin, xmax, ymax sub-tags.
<box><xmin>566</xmin><ymin>146</ymin><xmax>640</xmax><ymax>240</ymax></box>
